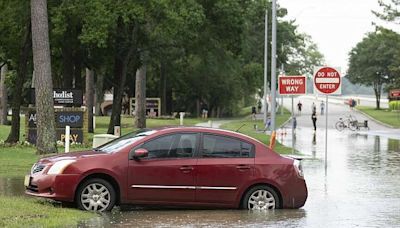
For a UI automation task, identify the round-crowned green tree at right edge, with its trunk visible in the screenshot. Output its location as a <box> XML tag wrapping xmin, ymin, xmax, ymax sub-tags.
<box><xmin>347</xmin><ymin>28</ymin><xmax>400</xmax><ymax>109</ymax></box>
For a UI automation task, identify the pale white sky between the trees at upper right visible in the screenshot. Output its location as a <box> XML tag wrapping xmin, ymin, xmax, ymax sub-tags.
<box><xmin>277</xmin><ymin>0</ymin><xmax>390</xmax><ymax>73</ymax></box>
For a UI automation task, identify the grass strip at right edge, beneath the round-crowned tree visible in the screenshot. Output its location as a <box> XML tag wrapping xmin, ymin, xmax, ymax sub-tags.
<box><xmin>357</xmin><ymin>106</ymin><xmax>400</xmax><ymax>128</ymax></box>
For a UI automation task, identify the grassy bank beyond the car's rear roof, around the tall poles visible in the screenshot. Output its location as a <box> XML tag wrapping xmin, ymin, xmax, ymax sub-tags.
<box><xmin>221</xmin><ymin>109</ymin><xmax>292</xmax><ymax>154</ymax></box>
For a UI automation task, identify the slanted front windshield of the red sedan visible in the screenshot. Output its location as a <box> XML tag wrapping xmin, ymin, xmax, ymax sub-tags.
<box><xmin>94</xmin><ymin>130</ymin><xmax>156</xmax><ymax>153</ymax></box>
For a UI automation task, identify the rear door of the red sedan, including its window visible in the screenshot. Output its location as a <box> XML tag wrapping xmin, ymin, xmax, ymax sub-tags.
<box><xmin>196</xmin><ymin>134</ymin><xmax>254</xmax><ymax>205</ymax></box>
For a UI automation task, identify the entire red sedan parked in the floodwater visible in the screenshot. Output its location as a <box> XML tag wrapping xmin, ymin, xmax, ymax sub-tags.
<box><xmin>25</xmin><ymin>127</ymin><xmax>307</xmax><ymax>211</ymax></box>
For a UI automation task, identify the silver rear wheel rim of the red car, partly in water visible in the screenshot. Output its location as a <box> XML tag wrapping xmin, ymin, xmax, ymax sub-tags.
<box><xmin>248</xmin><ymin>190</ymin><xmax>276</xmax><ymax>210</ymax></box>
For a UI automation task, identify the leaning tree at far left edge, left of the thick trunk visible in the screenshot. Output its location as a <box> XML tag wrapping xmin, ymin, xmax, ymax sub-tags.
<box><xmin>0</xmin><ymin>0</ymin><xmax>32</xmax><ymax>143</ymax></box>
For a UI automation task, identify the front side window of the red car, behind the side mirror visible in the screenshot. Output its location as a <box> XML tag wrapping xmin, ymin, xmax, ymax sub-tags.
<box><xmin>141</xmin><ymin>134</ymin><xmax>197</xmax><ymax>158</ymax></box>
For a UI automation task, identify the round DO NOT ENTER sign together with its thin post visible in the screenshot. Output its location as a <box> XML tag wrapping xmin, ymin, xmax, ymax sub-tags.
<box><xmin>313</xmin><ymin>66</ymin><xmax>342</xmax><ymax>175</ymax></box>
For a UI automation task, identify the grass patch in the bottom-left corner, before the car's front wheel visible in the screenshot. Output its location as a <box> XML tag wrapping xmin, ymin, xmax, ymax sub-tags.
<box><xmin>0</xmin><ymin>195</ymin><xmax>96</xmax><ymax>227</ymax></box>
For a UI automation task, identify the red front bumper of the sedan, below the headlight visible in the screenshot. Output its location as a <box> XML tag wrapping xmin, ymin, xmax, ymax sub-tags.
<box><xmin>25</xmin><ymin>174</ymin><xmax>79</xmax><ymax>202</ymax></box>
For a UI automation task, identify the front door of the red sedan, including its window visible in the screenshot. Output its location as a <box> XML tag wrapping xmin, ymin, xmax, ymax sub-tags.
<box><xmin>128</xmin><ymin>133</ymin><xmax>199</xmax><ymax>203</ymax></box>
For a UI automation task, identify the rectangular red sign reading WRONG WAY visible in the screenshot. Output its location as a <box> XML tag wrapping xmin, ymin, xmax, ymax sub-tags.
<box><xmin>278</xmin><ymin>76</ymin><xmax>307</xmax><ymax>95</ymax></box>
